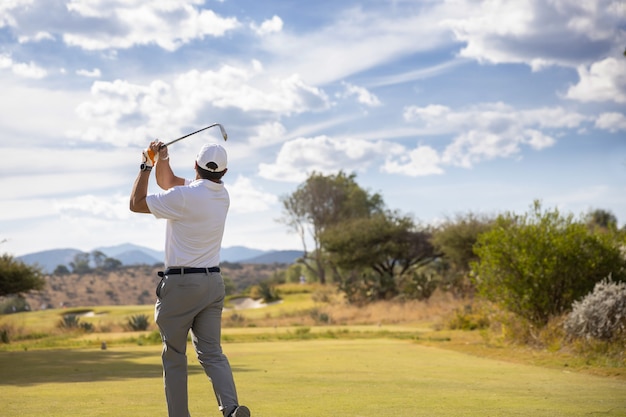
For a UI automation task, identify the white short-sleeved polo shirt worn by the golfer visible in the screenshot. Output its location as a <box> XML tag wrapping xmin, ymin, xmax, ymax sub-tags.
<box><xmin>146</xmin><ymin>179</ymin><xmax>230</xmax><ymax>268</ymax></box>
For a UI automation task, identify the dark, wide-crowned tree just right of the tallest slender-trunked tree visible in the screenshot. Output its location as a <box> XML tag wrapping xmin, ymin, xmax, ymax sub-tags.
<box><xmin>321</xmin><ymin>212</ymin><xmax>438</xmax><ymax>301</ymax></box>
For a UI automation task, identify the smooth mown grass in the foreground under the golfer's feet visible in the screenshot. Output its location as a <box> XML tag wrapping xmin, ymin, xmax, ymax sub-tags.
<box><xmin>0</xmin><ymin>338</ymin><xmax>626</xmax><ymax>417</ymax></box>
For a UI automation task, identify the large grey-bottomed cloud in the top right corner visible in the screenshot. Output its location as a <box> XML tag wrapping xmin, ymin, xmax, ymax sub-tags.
<box><xmin>444</xmin><ymin>0</ymin><xmax>626</xmax><ymax>70</ymax></box>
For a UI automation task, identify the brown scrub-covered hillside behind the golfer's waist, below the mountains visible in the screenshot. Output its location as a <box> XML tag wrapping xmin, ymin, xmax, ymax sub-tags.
<box><xmin>26</xmin><ymin>263</ymin><xmax>285</xmax><ymax>310</ymax></box>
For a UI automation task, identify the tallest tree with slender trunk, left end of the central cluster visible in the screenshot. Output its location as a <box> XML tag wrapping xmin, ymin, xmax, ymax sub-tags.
<box><xmin>281</xmin><ymin>171</ymin><xmax>384</xmax><ymax>284</ymax></box>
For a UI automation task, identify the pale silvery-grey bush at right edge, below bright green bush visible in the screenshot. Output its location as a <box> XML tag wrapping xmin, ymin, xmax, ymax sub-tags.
<box><xmin>564</xmin><ymin>277</ymin><xmax>626</xmax><ymax>342</ymax></box>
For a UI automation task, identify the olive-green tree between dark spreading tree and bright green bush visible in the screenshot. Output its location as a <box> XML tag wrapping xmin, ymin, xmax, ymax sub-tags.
<box><xmin>432</xmin><ymin>212</ymin><xmax>495</xmax><ymax>295</ymax></box>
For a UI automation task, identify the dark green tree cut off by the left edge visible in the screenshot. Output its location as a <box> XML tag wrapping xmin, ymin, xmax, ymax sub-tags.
<box><xmin>0</xmin><ymin>253</ymin><xmax>46</xmax><ymax>297</ymax></box>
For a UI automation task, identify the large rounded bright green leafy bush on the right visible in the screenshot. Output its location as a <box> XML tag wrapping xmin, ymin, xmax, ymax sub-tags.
<box><xmin>472</xmin><ymin>201</ymin><xmax>626</xmax><ymax>325</ymax></box>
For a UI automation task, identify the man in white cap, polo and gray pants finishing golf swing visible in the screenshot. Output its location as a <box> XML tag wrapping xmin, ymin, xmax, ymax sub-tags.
<box><xmin>130</xmin><ymin>141</ymin><xmax>250</xmax><ymax>417</ymax></box>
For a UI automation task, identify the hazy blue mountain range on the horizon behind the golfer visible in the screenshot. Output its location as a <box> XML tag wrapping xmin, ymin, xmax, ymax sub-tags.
<box><xmin>17</xmin><ymin>243</ymin><xmax>302</xmax><ymax>274</ymax></box>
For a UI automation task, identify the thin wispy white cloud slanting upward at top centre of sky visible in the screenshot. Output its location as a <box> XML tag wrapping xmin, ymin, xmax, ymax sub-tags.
<box><xmin>261</xmin><ymin>2</ymin><xmax>454</xmax><ymax>85</ymax></box>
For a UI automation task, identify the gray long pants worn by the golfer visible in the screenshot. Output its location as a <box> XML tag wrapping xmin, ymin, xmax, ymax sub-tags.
<box><xmin>154</xmin><ymin>272</ymin><xmax>238</xmax><ymax>417</ymax></box>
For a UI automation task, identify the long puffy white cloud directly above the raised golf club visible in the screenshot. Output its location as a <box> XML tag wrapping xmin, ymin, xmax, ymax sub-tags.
<box><xmin>68</xmin><ymin>65</ymin><xmax>330</xmax><ymax>146</ymax></box>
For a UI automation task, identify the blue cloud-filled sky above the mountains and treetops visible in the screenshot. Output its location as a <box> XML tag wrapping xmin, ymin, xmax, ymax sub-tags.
<box><xmin>0</xmin><ymin>0</ymin><xmax>626</xmax><ymax>256</ymax></box>
